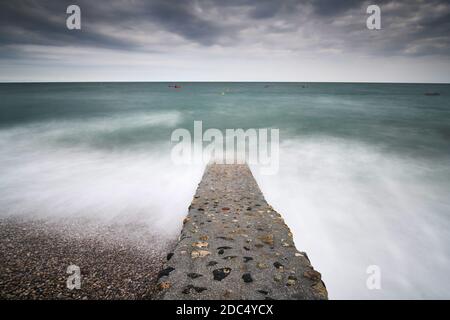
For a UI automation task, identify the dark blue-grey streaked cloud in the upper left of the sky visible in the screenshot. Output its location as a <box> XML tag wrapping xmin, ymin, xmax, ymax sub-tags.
<box><xmin>0</xmin><ymin>0</ymin><xmax>225</xmax><ymax>49</ymax></box>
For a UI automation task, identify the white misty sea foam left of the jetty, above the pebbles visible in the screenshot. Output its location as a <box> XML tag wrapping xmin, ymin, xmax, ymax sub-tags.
<box><xmin>0</xmin><ymin>113</ymin><xmax>203</xmax><ymax>237</ymax></box>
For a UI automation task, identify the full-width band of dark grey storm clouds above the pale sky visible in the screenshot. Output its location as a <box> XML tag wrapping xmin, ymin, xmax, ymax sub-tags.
<box><xmin>0</xmin><ymin>0</ymin><xmax>450</xmax><ymax>55</ymax></box>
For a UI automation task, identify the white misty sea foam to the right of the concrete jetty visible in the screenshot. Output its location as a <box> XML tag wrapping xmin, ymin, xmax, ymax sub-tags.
<box><xmin>252</xmin><ymin>138</ymin><xmax>450</xmax><ymax>299</ymax></box>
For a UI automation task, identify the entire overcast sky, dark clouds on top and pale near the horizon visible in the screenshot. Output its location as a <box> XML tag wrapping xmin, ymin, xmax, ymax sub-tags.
<box><xmin>0</xmin><ymin>0</ymin><xmax>450</xmax><ymax>83</ymax></box>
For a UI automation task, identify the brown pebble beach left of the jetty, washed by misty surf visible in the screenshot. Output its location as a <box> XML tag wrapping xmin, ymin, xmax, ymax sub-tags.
<box><xmin>0</xmin><ymin>218</ymin><xmax>173</xmax><ymax>300</ymax></box>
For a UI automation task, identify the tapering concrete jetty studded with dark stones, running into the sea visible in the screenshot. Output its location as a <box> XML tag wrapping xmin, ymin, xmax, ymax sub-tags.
<box><xmin>156</xmin><ymin>164</ymin><xmax>328</xmax><ymax>300</ymax></box>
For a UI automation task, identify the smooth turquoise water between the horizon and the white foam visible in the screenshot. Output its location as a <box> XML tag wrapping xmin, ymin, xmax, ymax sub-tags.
<box><xmin>0</xmin><ymin>83</ymin><xmax>450</xmax><ymax>157</ymax></box>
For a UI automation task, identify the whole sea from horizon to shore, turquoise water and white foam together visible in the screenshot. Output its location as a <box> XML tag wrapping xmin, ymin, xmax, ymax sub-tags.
<box><xmin>0</xmin><ymin>83</ymin><xmax>450</xmax><ymax>298</ymax></box>
